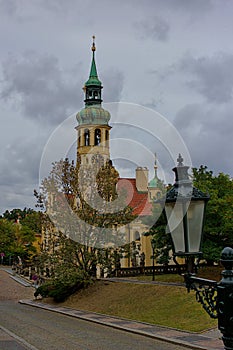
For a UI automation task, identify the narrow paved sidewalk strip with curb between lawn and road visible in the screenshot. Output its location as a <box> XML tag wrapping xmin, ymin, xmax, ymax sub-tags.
<box><xmin>19</xmin><ymin>300</ymin><xmax>223</xmax><ymax>350</ymax></box>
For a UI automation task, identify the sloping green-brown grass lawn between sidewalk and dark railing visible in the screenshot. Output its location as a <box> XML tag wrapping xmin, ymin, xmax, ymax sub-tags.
<box><xmin>62</xmin><ymin>281</ymin><xmax>217</xmax><ymax>332</ymax></box>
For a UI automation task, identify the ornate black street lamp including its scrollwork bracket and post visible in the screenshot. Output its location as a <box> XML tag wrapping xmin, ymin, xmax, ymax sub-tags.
<box><xmin>165</xmin><ymin>155</ymin><xmax>233</xmax><ymax>350</ymax></box>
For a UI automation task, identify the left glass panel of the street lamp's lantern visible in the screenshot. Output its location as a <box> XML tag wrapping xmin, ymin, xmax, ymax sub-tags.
<box><xmin>165</xmin><ymin>201</ymin><xmax>185</xmax><ymax>253</ymax></box>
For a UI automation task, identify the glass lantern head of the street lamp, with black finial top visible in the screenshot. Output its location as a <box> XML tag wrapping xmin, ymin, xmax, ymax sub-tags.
<box><xmin>165</xmin><ymin>154</ymin><xmax>209</xmax><ymax>272</ymax></box>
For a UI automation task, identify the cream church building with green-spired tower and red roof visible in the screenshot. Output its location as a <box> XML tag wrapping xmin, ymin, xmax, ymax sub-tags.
<box><xmin>76</xmin><ymin>36</ymin><xmax>162</xmax><ymax>267</ymax></box>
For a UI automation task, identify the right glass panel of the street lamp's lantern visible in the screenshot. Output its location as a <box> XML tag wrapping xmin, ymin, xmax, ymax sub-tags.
<box><xmin>187</xmin><ymin>200</ymin><xmax>205</xmax><ymax>253</ymax></box>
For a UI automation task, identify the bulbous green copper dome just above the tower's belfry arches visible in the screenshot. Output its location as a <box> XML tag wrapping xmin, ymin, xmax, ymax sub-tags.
<box><xmin>76</xmin><ymin>105</ymin><xmax>111</xmax><ymax>125</ymax></box>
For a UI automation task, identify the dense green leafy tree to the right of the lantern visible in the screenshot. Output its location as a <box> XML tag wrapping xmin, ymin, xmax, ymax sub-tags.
<box><xmin>193</xmin><ymin>166</ymin><xmax>233</xmax><ymax>264</ymax></box>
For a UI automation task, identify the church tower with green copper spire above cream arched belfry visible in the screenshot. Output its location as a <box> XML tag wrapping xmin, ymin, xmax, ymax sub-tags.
<box><xmin>76</xmin><ymin>36</ymin><xmax>111</xmax><ymax>166</ymax></box>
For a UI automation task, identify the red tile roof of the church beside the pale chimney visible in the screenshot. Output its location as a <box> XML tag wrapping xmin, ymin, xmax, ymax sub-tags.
<box><xmin>117</xmin><ymin>178</ymin><xmax>152</xmax><ymax>216</ymax></box>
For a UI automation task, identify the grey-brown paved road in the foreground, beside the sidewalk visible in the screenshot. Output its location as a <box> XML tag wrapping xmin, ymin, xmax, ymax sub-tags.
<box><xmin>0</xmin><ymin>271</ymin><xmax>186</xmax><ymax>350</ymax></box>
